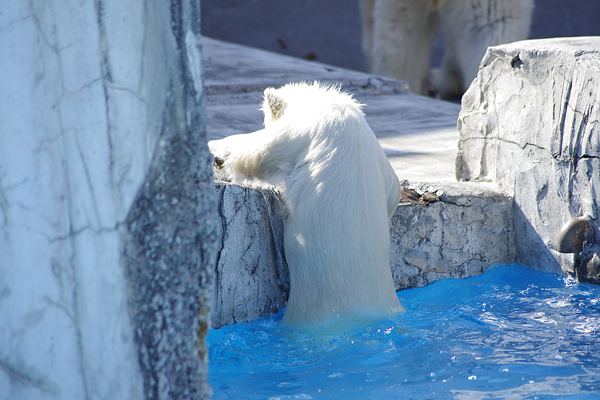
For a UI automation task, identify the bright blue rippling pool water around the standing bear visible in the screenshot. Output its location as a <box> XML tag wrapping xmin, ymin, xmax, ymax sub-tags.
<box><xmin>208</xmin><ymin>266</ymin><xmax>600</xmax><ymax>399</ymax></box>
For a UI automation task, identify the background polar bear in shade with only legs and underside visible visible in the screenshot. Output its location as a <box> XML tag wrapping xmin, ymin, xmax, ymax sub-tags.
<box><xmin>360</xmin><ymin>0</ymin><xmax>534</xmax><ymax>98</ymax></box>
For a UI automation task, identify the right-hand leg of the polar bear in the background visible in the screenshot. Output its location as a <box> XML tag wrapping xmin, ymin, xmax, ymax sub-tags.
<box><xmin>438</xmin><ymin>0</ymin><xmax>533</xmax><ymax>98</ymax></box>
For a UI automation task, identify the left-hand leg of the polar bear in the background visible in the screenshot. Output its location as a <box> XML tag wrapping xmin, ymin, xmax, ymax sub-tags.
<box><xmin>371</xmin><ymin>0</ymin><xmax>437</xmax><ymax>94</ymax></box>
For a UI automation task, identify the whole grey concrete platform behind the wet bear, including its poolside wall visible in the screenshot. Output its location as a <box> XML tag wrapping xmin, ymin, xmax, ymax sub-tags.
<box><xmin>203</xmin><ymin>37</ymin><xmax>514</xmax><ymax>327</ymax></box>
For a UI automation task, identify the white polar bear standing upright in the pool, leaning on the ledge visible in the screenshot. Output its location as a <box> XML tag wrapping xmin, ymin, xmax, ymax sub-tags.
<box><xmin>208</xmin><ymin>83</ymin><xmax>403</xmax><ymax>330</ymax></box>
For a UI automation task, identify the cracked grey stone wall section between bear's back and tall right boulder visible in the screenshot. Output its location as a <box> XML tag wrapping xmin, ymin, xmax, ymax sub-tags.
<box><xmin>390</xmin><ymin>182</ymin><xmax>514</xmax><ymax>290</ymax></box>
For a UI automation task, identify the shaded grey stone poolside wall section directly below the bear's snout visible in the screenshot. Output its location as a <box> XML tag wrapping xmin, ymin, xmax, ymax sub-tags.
<box><xmin>211</xmin><ymin>183</ymin><xmax>289</xmax><ymax>328</ymax></box>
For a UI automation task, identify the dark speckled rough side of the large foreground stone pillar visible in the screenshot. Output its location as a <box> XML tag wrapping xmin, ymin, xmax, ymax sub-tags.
<box><xmin>124</xmin><ymin>0</ymin><xmax>218</xmax><ymax>400</ymax></box>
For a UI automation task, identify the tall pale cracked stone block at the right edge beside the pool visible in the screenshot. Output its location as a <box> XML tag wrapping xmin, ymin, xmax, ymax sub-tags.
<box><xmin>457</xmin><ymin>37</ymin><xmax>600</xmax><ymax>276</ymax></box>
